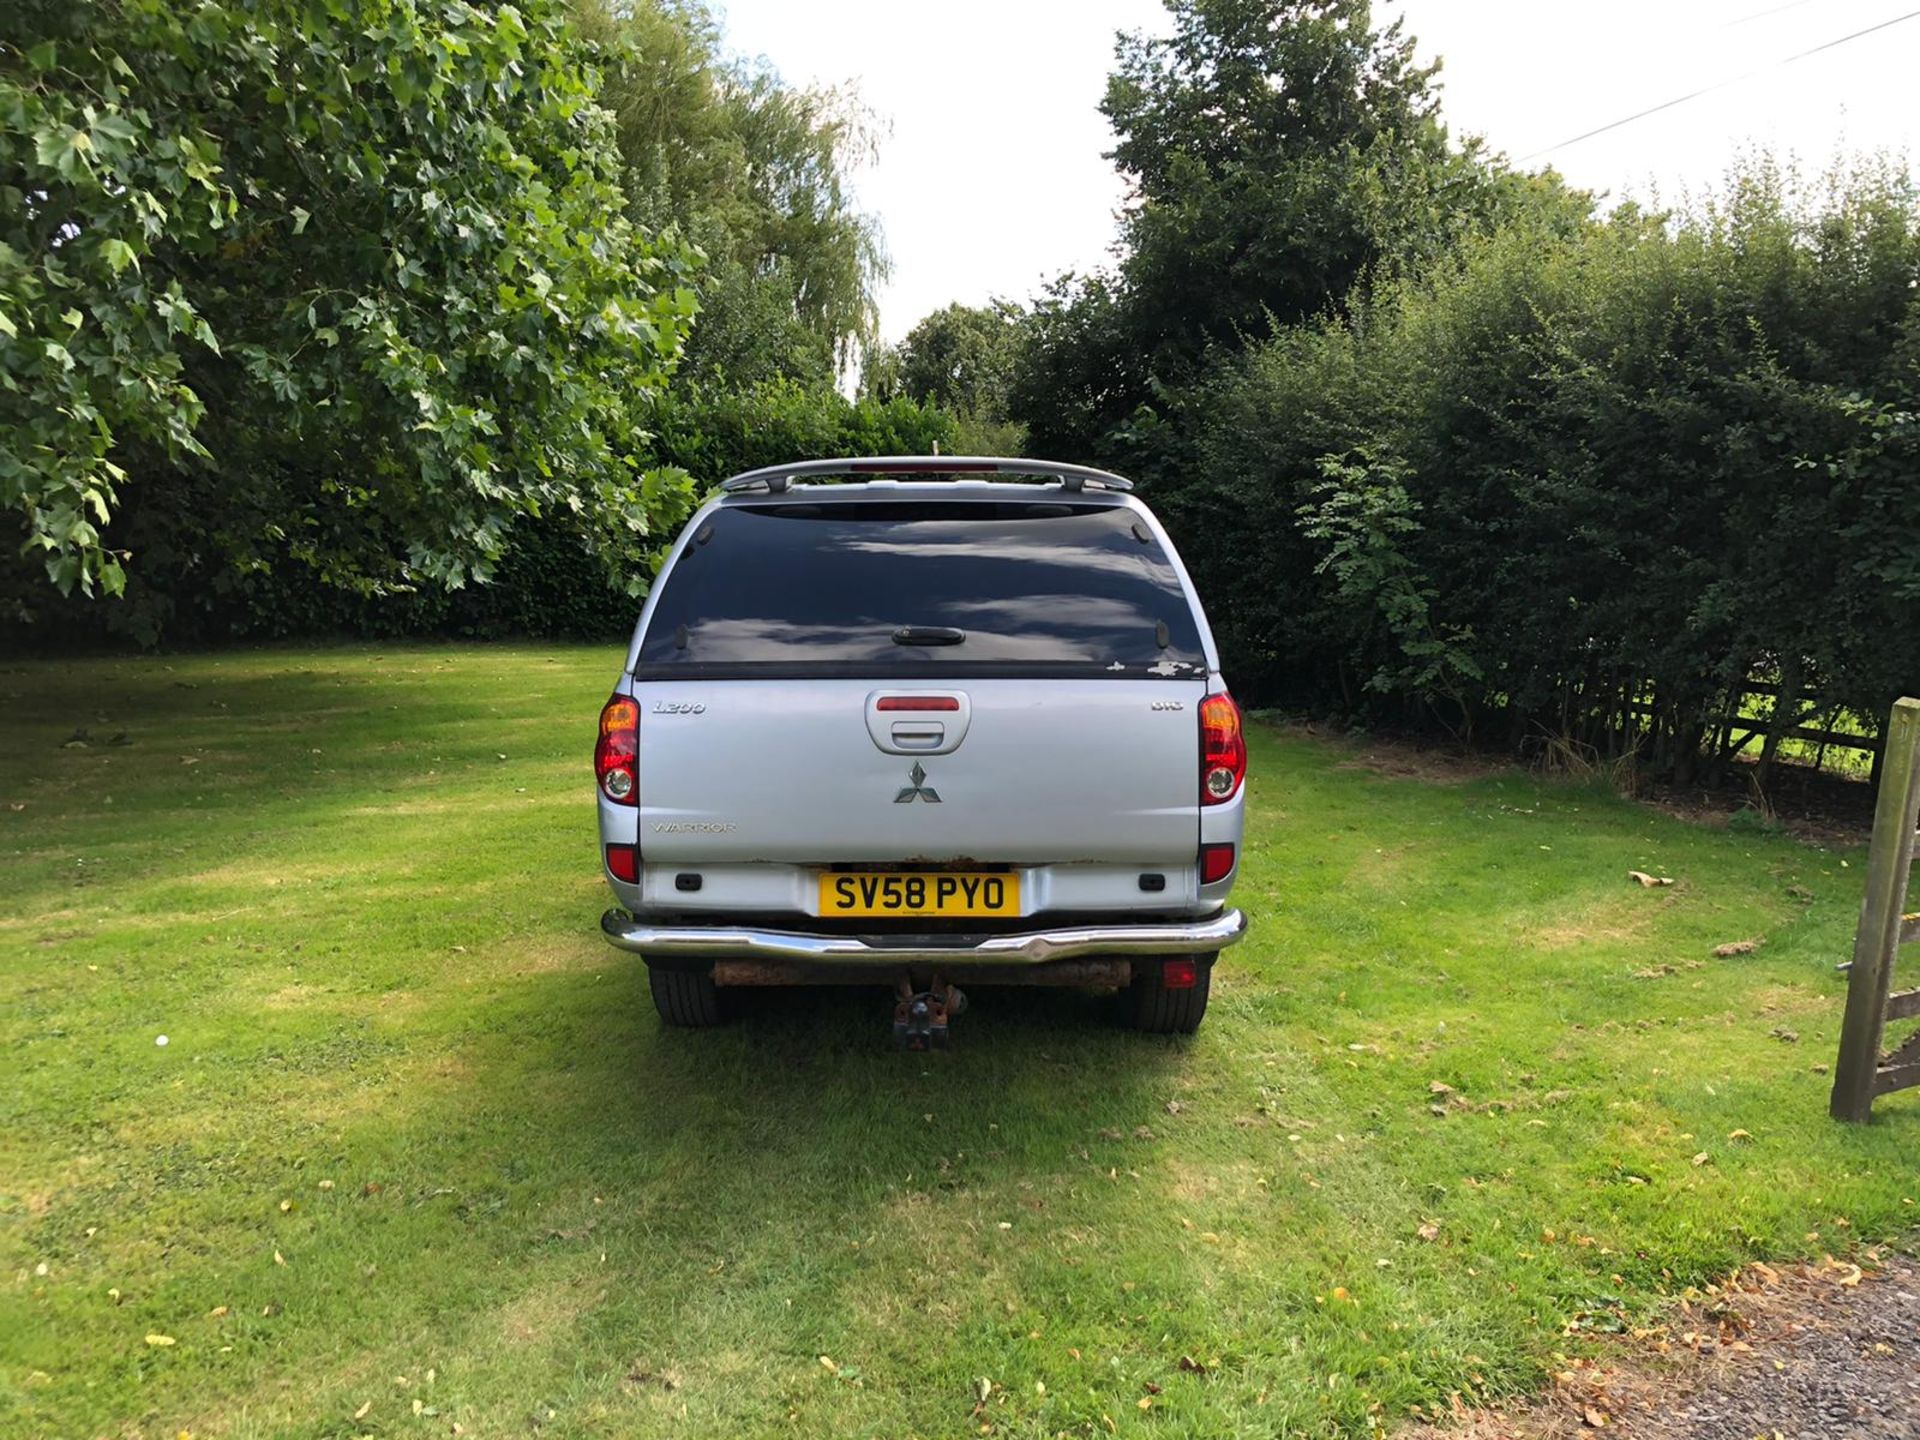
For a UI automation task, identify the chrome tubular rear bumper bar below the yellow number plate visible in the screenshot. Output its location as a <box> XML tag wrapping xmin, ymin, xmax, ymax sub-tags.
<box><xmin>601</xmin><ymin>910</ymin><xmax>1246</xmax><ymax>966</ymax></box>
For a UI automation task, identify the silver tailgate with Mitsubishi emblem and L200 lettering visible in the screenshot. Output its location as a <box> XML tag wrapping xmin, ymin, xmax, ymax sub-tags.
<box><xmin>634</xmin><ymin>678</ymin><xmax>1206</xmax><ymax>866</ymax></box>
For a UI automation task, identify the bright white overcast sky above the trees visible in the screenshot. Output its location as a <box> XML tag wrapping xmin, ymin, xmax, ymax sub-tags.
<box><xmin>724</xmin><ymin>0</ymin><xmax>1920</xmax><ymax>340</ymax></box>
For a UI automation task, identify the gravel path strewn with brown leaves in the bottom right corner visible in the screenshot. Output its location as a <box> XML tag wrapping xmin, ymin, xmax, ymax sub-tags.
<box><xmin>1404</xmin><ymin>1256</ymin><xmax>1920</xmax><ymax>1440</ymax></box>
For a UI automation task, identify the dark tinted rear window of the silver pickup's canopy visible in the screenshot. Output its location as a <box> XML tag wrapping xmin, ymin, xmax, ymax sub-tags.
<box><xmin>637</xmin><ymin>501</ymin><xmax>1206</xmax><ymax>680</ymax></box>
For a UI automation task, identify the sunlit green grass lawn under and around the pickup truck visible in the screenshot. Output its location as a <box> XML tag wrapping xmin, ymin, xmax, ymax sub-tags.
<box><xmin>0</xmin><ymin>647</ymin><xmax>1920</xmax><ymax>1440</ymax></box>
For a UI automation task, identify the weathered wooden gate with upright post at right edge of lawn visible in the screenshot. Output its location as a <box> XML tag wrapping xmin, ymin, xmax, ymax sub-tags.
<box><xmin>1828</xmin><ymin>699</ymin><xmax>1920</xmax><ymax>1121</ymax></box>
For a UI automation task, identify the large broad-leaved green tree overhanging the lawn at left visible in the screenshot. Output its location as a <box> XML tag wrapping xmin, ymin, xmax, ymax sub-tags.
<box><xmin>0</xmin><ymin>0</ymin><xmax>693</xmax><ymax>625</ymax></box>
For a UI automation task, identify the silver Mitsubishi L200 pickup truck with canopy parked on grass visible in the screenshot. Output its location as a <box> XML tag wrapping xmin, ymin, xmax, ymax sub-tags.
<box><xmin>593</xmin><ymin>457</ymin><xmax>1246</xmax><ymax>1048</ymax></box>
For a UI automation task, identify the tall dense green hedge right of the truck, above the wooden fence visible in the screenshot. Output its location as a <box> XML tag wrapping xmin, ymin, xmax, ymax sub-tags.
<box><xmin>1156</xmin><ymin>161</ymin><xmax>1920</xmax><ymax>774</ymax></box>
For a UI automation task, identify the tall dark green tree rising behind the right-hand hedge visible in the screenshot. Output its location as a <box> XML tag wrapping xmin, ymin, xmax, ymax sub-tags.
<box><xmin>1014</xmin><ymin>0</ymin><xmax>1551</xmax><ymax>459</ymax></box>
